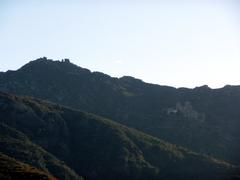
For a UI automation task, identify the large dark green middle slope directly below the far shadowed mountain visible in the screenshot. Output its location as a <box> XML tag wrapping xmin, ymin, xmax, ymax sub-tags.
<box><xmin>0</xmin><ymin>93</ymin><xmax>237</xmax><ymax>180</ymax></box>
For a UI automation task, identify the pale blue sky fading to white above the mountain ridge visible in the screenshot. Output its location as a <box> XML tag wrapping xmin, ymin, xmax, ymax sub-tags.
<box><xmin>0</xmin><ymin>0</ymin><xmax>240</xmax><ymax>88</ymax></box>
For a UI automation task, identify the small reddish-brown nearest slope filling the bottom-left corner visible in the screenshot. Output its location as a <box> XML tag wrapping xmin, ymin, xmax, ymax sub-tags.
<box><xmin>0</xmin><ymin>153</ymin><xmax>56</xmax><ymax>180</ymax></box>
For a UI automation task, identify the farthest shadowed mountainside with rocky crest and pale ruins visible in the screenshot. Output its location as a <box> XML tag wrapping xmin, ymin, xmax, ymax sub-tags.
<box><xmin>0</xmin><ymin>58</ymin><xmax>240</xmax><ymax>165</ymax></box>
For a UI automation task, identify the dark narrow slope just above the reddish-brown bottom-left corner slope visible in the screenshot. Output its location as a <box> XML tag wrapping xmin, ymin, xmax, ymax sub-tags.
<box><xmin>0</xmin><ymin>122</ymin><xmax>82</xmax><ymax>180</ymax></box>
